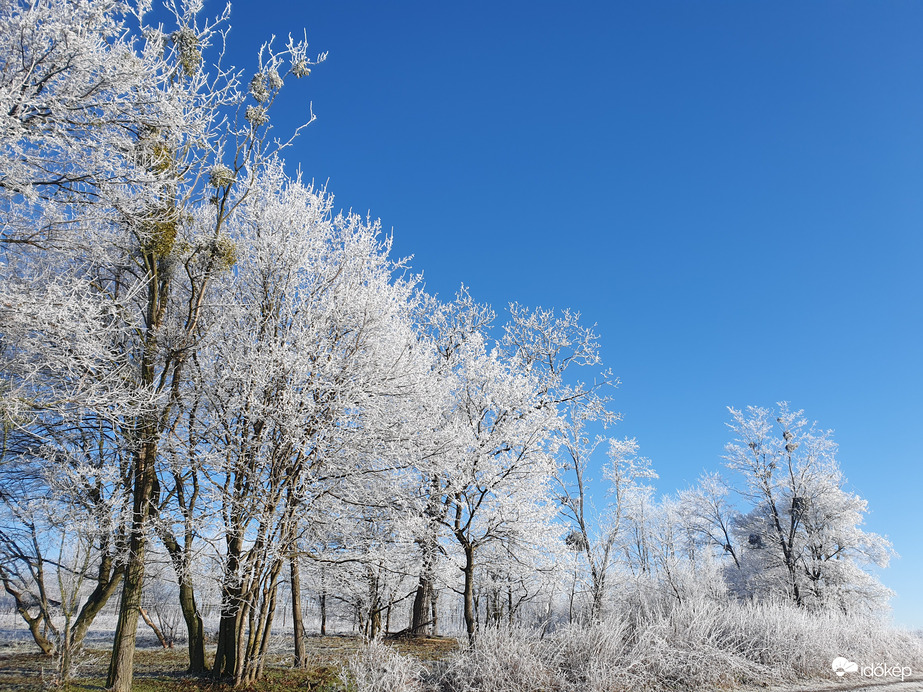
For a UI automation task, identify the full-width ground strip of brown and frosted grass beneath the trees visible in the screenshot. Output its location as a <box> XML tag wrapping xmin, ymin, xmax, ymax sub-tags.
<box><xmin>0</xmin><ymin>598</ymin><xmax>923</xmax><ymax>692</ymax></box>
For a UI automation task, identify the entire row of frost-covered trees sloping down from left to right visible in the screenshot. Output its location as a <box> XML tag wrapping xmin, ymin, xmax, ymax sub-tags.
<box><xmin>0</xmin><ymin>0</ymin><xmax>890</xmax><ymax>690</ymax></box>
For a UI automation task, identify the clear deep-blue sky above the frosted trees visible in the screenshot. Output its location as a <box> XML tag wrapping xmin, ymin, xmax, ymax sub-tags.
<box><xmin>222</xmin><ymin>0</ymin><xmax>923</xmax><ymax>627</ymax></box>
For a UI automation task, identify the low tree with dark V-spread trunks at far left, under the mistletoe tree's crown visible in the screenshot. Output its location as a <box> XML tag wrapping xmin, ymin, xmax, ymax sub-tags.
<box><xmin>0</xmin><ymin>412</ymin><xmax>129</xmax><ymax>679</ymax></box>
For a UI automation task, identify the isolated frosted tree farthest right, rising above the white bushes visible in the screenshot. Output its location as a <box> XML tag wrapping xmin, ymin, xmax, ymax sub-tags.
<box><xmin>725</xmin><ymin>403</ymin><xmax>892</xmax><ymax>611</ymax></box>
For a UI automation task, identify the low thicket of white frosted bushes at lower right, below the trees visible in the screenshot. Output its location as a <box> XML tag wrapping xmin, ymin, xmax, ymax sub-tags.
<box><xmin>408</xmin><ymin>598</ymin><xmax>923</xmax><ymax>692</ymax></box>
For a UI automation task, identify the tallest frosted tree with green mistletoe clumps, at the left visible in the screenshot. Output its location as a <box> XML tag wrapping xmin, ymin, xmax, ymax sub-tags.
<box><xmin>0</xmin><ymin>0</ymin><xmax>324</xmax><ymax>690</ymax></box>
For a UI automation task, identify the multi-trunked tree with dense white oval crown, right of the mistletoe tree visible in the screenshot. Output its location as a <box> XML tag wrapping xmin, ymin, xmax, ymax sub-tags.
<box><xmin>190</xmin><ymin>166</ymin><xmax>425</xmax><ymax>683</ymax></box>
